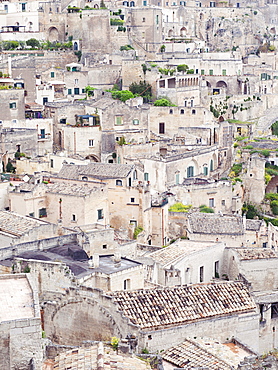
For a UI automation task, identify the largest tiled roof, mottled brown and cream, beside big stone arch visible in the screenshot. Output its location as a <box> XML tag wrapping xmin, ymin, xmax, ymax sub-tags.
<box><xmin>112</xmin><ymin>282</ymin><xmax>256</xmax><ymax>329</ymax></box>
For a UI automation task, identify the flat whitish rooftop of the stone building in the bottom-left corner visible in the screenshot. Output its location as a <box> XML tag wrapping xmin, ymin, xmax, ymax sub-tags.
<box><xmin>0</xmin><ymin>275</ymin><xmax>35</xmax><ymax>322</ymax></box>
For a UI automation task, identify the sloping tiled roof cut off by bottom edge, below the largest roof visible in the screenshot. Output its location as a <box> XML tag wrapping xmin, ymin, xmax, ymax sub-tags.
<box><xmin>162</xmin><ymin>339</ymin><xmax>232</xmax><ymax>370</ymax></box>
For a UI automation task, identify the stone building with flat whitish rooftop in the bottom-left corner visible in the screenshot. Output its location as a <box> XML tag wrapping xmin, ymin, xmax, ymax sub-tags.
<box><xmin>0</xmin><ymin>274</ymin><xmax>43</xmax><ymax>369</ymax></box>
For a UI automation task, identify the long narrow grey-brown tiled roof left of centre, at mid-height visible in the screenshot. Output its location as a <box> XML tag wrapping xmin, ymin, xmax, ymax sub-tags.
<box><xmin>58</xmin><ymin>163</ymin><xmax>133</xmax><ymax>179</ymax></box>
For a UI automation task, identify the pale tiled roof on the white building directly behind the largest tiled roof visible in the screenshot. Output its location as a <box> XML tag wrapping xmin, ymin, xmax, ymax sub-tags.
<box><xmin>148</xmin><ymin>240</ymin><xmax>215</xmax><ymax>266</ymax></box>
